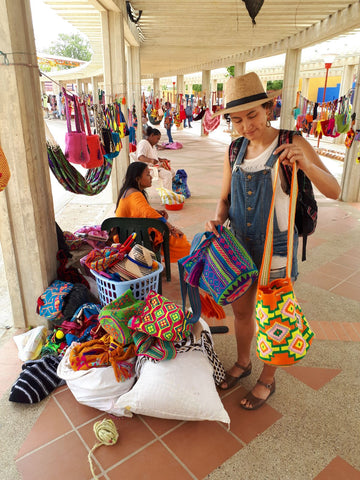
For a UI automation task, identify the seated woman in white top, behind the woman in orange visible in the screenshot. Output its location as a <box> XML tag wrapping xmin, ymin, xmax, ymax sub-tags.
<box><xmin>136</xmin><ymin>126</ymin><xmax>175</xmax><ymax>190</ymax></box>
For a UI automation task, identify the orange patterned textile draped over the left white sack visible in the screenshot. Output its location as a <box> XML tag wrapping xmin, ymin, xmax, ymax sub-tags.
<box><xmin>69</xmin><ymin>335</ymin><xmax>135</xmax><ymax>382</ymax></box>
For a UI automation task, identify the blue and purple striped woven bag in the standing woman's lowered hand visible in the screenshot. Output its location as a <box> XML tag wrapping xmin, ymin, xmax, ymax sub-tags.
<box><xmin>179</xmin><ymin>225</ymin><xmax>258</xmax><ymax>305</ymax></box>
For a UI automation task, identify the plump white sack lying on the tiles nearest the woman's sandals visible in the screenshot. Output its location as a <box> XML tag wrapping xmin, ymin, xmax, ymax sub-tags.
<box><xmin>112</xmin><ymin>322</ymin><xmax>230</xmax><ymax>425</ymax></box>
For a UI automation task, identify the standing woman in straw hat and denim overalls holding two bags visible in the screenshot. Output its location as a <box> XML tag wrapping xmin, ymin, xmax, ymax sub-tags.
<box><xmin>206</xmin><ymin>72</ymin><xmax>340</xmax><ymax>410</ymax></box>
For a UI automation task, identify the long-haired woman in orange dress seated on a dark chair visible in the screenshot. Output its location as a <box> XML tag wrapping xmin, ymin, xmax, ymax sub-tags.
<box><xmin>115</xmin><ymin>162</ymin><xmax>190</xmax><ymax>263</ymax></box>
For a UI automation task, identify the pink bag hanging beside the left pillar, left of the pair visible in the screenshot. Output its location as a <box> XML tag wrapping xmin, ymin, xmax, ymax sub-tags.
<box><xmin>63</xmin><ymin>89</ymin><xmax>90</xmax><ymax>168</ymax></box>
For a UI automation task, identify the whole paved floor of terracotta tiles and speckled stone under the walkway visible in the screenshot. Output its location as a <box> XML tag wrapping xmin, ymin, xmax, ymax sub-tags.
<box><xmin>0</xmin><ymin>120</ymin><xmax>360</xmax><ymax>480</ymax></box>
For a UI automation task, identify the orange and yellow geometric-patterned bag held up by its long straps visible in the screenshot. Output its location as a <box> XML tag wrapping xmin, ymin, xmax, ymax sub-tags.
<box><xmin>256</xmin><ymin>161</ymin><xmax>314</xmax><ymax>367</ymax></box>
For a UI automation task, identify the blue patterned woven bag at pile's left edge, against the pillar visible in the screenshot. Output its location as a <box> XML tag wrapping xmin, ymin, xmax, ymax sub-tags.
<box><xmin>36</xmin><ymin>280</ymin><xmax>73</xmax><ymax>320</ymax></box>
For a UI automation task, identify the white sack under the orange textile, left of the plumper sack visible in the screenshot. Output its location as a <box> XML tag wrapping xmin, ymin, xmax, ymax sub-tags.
<box><xmin>57</xmin><ymin>346</ymin><xmax>135</xmax><ymax>417</ymax></box>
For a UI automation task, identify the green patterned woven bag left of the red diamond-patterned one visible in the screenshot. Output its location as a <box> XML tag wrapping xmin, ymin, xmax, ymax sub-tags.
<box><xmin>99</xmin><ymin>289</ymin><xmax>145</xmax><ymax>345</ymax></box>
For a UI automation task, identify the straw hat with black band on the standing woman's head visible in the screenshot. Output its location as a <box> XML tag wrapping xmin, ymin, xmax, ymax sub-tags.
<box><xmin>213</xmin><ymin>72</ymin><xmax>281</xmax><ymax>117</ymax></box>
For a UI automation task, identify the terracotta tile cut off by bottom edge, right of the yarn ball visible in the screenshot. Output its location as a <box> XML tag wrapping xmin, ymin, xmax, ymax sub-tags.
<box><xmin>107</xmin><ymin>442</ymin><xmax>192</xmax><ymax>480</ymax></box>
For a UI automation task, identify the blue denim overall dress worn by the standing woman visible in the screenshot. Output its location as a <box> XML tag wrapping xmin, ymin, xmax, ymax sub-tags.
<box><xmin>229</xmin><ymin>139</ymin><xmax>298</xmax><ymax>280</ymax></box>
